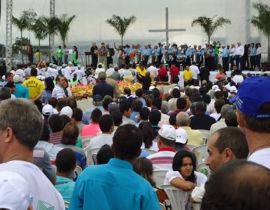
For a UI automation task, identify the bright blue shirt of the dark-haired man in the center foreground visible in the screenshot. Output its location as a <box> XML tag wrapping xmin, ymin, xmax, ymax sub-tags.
<box><xmin>69</xmin><ymin>158</ymin><xmax>160</xmax><ymax>210</ymax></box>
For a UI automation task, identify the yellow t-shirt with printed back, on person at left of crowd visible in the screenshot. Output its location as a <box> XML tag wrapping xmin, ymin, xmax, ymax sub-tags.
<box><xmin>23</xmin><ymin>76</ymin><xmax>45</xmax><ymax>99</ymax></box>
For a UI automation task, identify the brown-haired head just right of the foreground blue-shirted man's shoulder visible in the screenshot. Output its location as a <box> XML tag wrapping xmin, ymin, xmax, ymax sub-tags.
<box><xmin>133</xmin><ymin>157</ymin><xmax>156</xmax><ymax>187</ymax></box>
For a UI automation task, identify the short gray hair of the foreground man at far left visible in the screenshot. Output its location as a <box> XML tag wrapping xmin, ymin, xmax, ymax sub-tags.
<box><xmin>0</xmin><ymin>99</ymin><xmax>43</xmax><ymax>149</ymax></box>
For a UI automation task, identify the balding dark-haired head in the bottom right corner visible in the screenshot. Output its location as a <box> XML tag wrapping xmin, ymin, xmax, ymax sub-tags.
<box><xmin>201</xmin><ymin>160</ymin><xmax>270</xmax><ymax>210</ymax></box>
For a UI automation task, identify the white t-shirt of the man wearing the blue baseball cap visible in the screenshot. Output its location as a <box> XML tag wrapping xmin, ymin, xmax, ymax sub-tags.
<box><xmin>247</xmin><ymin>147</ymin><xmax>270</xmax><ymax>169</ymax></box>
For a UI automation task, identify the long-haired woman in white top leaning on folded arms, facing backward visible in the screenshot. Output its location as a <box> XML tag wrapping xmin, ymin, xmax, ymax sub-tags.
<box><xmin>164</xmin><ymin>150</ymin><xmax>207</xmax><ymax>191</ymax></box>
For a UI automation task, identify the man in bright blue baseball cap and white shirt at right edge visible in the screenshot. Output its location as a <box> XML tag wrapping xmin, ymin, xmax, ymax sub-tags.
<box><xmin>236</xmin><ymin>76</ymin><xmax>270</xmax><ymax>168</ymax></box>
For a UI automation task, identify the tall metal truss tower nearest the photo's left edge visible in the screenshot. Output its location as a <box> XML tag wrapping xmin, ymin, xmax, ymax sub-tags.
<box><xmin>6</xmin><ymin>0</ymin><xmax>13</xmax><ymax>71</ymax></box>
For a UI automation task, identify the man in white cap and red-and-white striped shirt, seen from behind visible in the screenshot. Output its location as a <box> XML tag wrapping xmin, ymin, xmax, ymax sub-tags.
<box><xmin>147</xmin><ymin>125</ymin><xmax>176</xmax><ymax>171</ymax></box>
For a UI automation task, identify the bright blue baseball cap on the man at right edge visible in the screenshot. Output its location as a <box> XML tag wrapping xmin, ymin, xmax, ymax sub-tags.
<box><xmin>235</xmin><ymin>76</ymin><xmax>270</xmax><ymax>119</ymax></box>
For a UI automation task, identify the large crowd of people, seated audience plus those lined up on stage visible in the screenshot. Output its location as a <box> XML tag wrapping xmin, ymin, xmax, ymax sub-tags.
<box><xmin>0</xmin><ymin>39</ymin><xmax>270</xmax><ymax>210</ymax></box>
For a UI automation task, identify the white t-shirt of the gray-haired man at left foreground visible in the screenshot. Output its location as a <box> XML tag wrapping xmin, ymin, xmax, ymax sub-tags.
<box><xmin>0</xmin><ymin>160</ymin><xmax>65</xmax><ymax>210</ymax></box>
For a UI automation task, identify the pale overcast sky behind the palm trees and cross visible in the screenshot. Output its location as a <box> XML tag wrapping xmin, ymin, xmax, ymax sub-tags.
<box><xmin>0</xmin><ymin>0</ymin><xmax>267</xmax><ymax>44</ymax></box>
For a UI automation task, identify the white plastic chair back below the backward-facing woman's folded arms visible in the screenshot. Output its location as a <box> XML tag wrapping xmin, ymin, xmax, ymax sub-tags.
<box><xmin>160</xmin><ymin>185</ymin><xmax>190</xmax><ymax>210</ymax></box>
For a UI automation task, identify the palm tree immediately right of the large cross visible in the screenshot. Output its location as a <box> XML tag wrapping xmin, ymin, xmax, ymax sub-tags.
<box><xmin>191</xmin><ymin>15</ymin><xmax>231</xmax><ymax>44</ymax></box>
